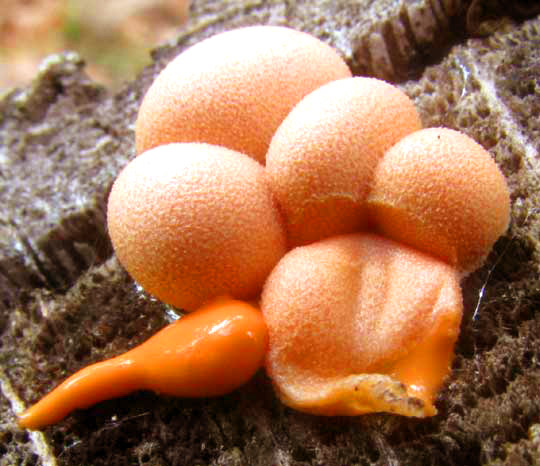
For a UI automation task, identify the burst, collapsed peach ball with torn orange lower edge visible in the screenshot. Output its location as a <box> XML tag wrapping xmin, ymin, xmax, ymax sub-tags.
<box><xmin>261</xmin><ymin>234</ymin><xmax>462</xmax><ymax>417</ymax></box>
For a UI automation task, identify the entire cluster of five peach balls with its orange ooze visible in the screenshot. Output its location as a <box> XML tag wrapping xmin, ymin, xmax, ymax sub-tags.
<box><xmin>21</xmin><ymin>26</ymin><xmax>510</xmax><ymax>427</ymax></box>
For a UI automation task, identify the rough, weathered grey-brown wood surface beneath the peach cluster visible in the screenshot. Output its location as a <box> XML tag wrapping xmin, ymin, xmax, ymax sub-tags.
<box><xmin>0</xmin><ymin>0</ymin><xmax>540</xmax><ymax>466</ymax></box>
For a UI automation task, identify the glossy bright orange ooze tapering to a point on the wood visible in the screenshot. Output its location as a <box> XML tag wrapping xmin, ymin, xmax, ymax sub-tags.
<box><xmin>19</xmin><ymin>298</ymin><xmax>268</xmax><ymax>429</ymax></box>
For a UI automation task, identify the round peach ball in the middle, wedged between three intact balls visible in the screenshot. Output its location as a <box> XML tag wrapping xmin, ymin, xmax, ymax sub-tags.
<box><xmin>266</xmin><ymin>78</ymin><xmax>421</xmax><ymax>246</ymax></box>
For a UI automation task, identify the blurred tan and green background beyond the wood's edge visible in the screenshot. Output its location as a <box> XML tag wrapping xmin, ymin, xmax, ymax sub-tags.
<box><xmin>0</xmin><ymin>0</ymin><xmax>190</xmax><ymax>95</ymax></box>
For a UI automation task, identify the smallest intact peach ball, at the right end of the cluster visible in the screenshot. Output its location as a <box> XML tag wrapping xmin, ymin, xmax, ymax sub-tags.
<box><xmin>368</xmin><ymin>128</ymin><xmax>510</xmax><ymax>273</ymax></box>
